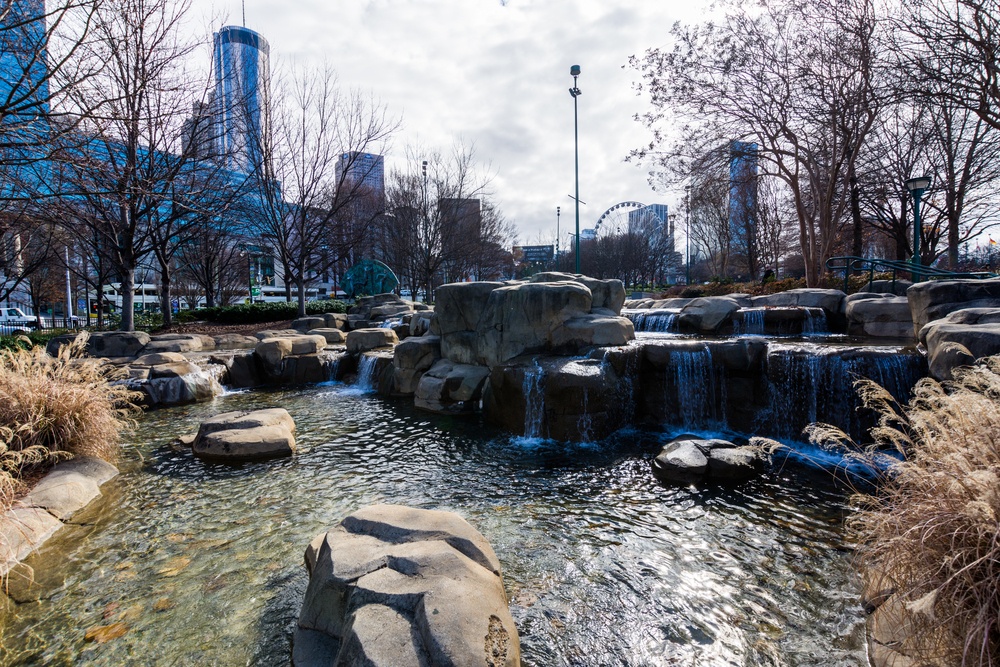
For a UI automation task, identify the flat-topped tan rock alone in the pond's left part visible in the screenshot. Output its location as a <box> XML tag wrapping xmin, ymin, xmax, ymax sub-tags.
<box><xmin>191</xmin><ymin>408</ymin><xmax>295</xmax><ymax>462</ymax></box>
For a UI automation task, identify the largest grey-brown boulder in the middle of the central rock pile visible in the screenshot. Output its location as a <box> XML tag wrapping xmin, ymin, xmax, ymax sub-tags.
<box><xmin>476</xmin><ymin>282</ymin><xmax>592</xmax><ymax>367</ymax></box>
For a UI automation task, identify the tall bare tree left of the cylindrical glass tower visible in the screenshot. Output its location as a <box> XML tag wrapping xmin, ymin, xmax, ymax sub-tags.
<box><xmin>56</xmin><ymin>0</ymin><xmax>207</xmax><ymax>330</ymax></box>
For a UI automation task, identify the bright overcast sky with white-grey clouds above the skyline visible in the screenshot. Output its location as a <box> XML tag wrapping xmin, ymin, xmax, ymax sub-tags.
<box><xmin>194</xmin><ymin>0</ymin><xmax>700</xmax><ymax>247</ymax></box>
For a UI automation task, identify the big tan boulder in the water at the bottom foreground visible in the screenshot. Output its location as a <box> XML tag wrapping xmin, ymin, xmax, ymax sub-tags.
<box><xmin>292</xmin><ymin>505</ymin><xmax>521</xmax><ymax>667</ymax></box>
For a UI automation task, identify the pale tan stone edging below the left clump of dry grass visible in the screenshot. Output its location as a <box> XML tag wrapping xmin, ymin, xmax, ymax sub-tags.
<box><xmin>0</xmin><ymin>457</ymin><xmax>118</xmax><ymax>589</ymax></box>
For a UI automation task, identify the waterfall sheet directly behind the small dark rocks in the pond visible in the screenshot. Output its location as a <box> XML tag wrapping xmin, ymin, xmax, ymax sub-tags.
<box><xmin>665</xmin><ymin>345</ymin><xmax>726</xmax><ymax>427</ymax></box>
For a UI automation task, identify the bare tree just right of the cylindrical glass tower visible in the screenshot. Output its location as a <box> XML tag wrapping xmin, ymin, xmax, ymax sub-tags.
<box><xmin>252</xmin><ymin>66</ymin><xmax>399</xmax><ymax>316</ymax></box>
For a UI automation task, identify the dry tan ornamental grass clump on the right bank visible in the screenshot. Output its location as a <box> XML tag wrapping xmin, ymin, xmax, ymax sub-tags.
<box><xmin>810</xmin><ymin>356</ymin><xmax>1000</xmax><ymax>666</ymax></box>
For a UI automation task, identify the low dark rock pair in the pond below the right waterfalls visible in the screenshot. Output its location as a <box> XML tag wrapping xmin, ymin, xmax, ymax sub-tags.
<box><xmin>653</xmin><ymin>436</ymin><xmax>763</xmax><ymax>484</ymax></box>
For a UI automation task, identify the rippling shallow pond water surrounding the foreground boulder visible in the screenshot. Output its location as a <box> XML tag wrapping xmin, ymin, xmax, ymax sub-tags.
<box><xmin>0</xmin><ymin>384</ymin><xmax>867</xmax><ymax>666</ymax></box>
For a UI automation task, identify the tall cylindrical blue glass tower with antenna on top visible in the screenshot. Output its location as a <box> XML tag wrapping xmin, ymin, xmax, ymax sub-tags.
<box><xmin>212</xmin><ymin>26</ymin><xmax>271</xmax><ymax>174</ymax></box>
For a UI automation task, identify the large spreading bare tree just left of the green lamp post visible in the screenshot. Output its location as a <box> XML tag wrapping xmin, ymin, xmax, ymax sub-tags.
<box><xmin>631</xmin><ymin>0</ymin><xmax>879</xmax><ymax>285</ymax></box>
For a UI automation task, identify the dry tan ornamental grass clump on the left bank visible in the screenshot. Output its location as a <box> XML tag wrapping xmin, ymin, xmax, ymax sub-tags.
<box><xmin>0</xmin><ymin>340</ymin><xmax>139</xmax><ymax>510</ymax></box>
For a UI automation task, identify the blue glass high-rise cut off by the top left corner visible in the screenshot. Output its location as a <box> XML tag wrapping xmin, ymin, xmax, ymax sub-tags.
<box><xmin>0</xmin><ymin>0</ymin><xmax>49</xmax><ymax>123</ymax></box>
